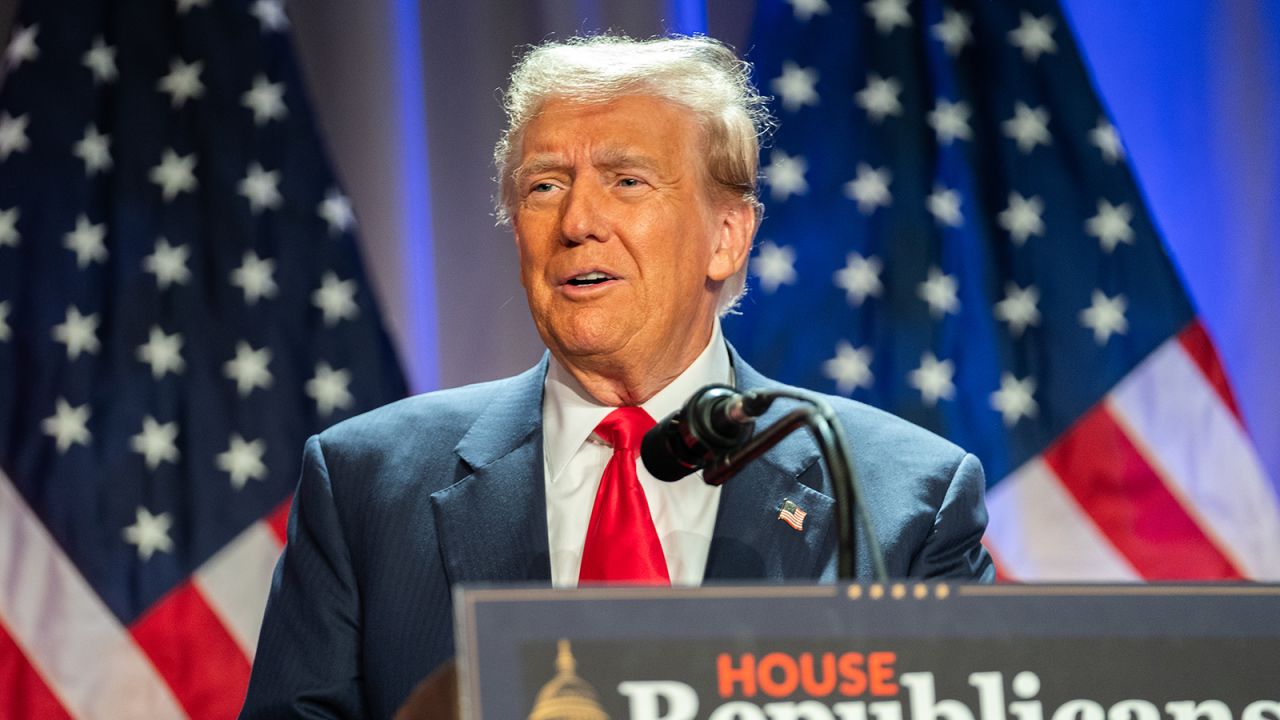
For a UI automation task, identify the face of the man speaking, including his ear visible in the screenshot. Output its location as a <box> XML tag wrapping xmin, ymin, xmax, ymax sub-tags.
<box><xmin>515</xmin><ymin>95</ymin><xmax>754</xmax><ymax>377</ymax></box>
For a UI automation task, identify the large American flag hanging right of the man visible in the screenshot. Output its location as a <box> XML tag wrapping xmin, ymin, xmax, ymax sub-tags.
<box><xmin>726</xmin><ymin>0</ymin><xmax>1280</xmax><ymax>580</ymax></box>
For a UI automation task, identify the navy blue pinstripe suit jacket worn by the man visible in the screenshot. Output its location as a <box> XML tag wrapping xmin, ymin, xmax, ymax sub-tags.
<box><xmin>242</xmin><ymin>348</ymin><xmax>993</xmax><ymax>719</ymax></box>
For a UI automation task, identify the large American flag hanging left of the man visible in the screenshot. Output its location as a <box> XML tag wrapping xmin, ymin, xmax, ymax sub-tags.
<box><xmin>0</xmin><ymin>0</ymin><xmax>404</xmax><ymax>717</ymax></box>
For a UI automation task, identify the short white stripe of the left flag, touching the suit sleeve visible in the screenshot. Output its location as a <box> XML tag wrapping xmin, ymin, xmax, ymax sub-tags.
<box><xmin>195</xmin><ymin>521</ymin><xmax>280</xmax><ymax>660</ymax></box>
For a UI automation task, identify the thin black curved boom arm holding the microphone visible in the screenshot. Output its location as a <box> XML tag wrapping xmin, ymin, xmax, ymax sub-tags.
<box><xmin>703</xmin><ymin>391</ymin><xmax>888</xmax><ymax>583</ymax></box>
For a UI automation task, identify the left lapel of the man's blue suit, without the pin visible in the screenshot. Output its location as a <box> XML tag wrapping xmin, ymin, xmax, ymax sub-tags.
<box><xmin>431</xmin><ymin>356</ymin><xmax>552</xmax><ymax>584</ymax></box>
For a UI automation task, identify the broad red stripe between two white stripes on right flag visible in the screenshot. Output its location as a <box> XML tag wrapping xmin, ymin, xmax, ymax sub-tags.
<box><xmin>1044</xmin><ymin>404</ymin><xmax>1240</xmax><ymax>580</ymax></box>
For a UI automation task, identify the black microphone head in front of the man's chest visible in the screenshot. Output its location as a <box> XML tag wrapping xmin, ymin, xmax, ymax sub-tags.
<box><xmin>640</xmin><ymin>384</ymin><xmax>772</xmax><ymax>483</ymax></box>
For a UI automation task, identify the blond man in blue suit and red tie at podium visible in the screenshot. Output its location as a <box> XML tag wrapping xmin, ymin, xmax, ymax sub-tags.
<box><xmin>244</xmin><ymin>37</ymin><xmax>992</xmax><ymax>717</ymax></box>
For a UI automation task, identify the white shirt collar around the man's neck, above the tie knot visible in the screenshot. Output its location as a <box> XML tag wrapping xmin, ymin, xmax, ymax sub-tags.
<box><xmin>543</xmin><ymin>322</ymin><xmax>733</xmax><ymax>483</ymax></box>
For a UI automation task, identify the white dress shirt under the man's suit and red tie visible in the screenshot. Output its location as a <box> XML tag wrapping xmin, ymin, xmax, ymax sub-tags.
<box><xmin>543</xmin><ymin>323</ymin><xmax>733</xmax><ymax>588</ymax></box>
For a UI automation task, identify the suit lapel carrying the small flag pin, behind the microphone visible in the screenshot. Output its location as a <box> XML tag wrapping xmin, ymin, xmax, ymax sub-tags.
<box><xmin>705</xmin><ymin>346</ymin><xmax>836</xmax><ymax>580</ymax></box>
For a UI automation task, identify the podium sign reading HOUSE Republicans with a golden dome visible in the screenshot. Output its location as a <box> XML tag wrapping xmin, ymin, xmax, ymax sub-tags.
<box><xmin>456</xmin><ymin>583</ymin><xmax>1280</xmax><ymax>720</ymax></box>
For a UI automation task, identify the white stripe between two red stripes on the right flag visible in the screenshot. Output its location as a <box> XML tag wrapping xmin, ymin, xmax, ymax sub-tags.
<box><xmin>1108</xmin><ymin>340</ymin><xmax>1280</xmax><ymax>580</ymax></box>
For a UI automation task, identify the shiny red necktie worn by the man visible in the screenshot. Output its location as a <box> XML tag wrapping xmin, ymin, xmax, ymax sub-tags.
<box><xmin>577</xmin><ymin>407</ymin><xmax>671</xmax><ymax>585</ymax></box>
